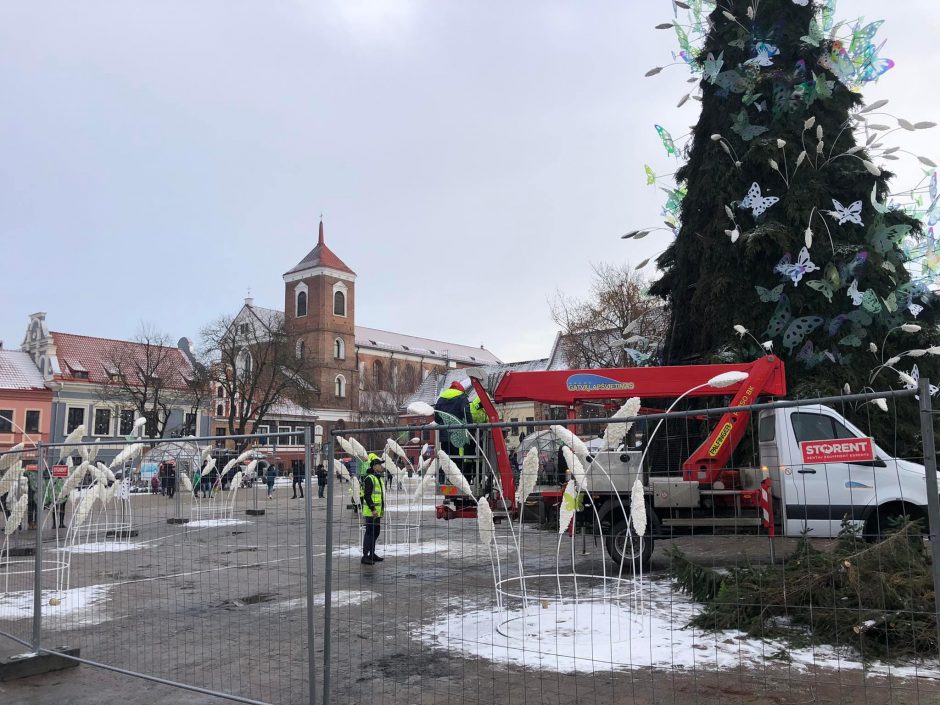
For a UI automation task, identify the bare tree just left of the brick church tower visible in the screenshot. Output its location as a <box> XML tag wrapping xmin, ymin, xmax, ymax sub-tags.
<box><xmin>202</xmin><ymin>307</ymin><xmax>320</xmax><ymax>447</ymax></box>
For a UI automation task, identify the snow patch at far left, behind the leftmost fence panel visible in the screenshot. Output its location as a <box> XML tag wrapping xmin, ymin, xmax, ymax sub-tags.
<box><xmin>0</xmin><ymin>585</ymin><xmax>113</xmax><ymax>630</ymax></box>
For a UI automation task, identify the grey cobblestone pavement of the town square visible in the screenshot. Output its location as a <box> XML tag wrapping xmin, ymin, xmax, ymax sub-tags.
<box><xmin>0</xmin><ymin>485</ymin><xmax>940</xmax><ymax>705</ymax></box>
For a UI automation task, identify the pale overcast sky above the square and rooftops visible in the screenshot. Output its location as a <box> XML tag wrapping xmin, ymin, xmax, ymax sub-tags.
<box><xmin>0</xmin><ymin>0</ymin><xmax>940</xmax><ymax>360</ymax></box>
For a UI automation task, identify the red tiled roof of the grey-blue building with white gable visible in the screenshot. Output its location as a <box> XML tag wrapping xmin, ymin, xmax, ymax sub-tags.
<box><xmin>50</xmin><ymin>331</ymin><xmax>192</xmax><ymax>389</ymax></box>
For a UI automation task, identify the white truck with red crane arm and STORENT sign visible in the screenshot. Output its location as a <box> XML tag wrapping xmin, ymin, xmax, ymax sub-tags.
<box><xmin>437</xmin><ymin>355</ymin><xmax>927</xmax><ymax>563</ymax></box>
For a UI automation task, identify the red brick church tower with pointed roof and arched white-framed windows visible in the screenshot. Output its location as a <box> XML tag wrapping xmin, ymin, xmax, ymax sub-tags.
<box><xmin>284</xmin><ymin>220</ymin><xmax>359</xmax><ymax>420</ymax></box>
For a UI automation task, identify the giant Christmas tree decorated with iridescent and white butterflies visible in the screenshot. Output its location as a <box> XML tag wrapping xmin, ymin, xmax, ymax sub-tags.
<box><xmin>647</xmin><ymin>0</ymin><xmax>940</xmax><ymax>438</ymax></box>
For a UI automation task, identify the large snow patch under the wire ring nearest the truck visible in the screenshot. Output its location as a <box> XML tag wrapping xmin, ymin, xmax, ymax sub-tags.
<box><xmin>414</xmin><ymin>581</ymin><xmax>940</xmax><ymax>678</ymax></box>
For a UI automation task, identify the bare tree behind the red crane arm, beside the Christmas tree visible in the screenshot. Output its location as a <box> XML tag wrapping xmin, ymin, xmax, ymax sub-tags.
<box><xmin>551</xmin><ymin>264</ymin><xmax>669</xmax><ymax>368</ymax></box>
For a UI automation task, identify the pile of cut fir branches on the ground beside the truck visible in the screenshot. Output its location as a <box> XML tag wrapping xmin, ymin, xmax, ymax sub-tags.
<box><xmin>670</xmin><ymin>521</ymin><xmax>938</xmax><ymax>660</ymax></box>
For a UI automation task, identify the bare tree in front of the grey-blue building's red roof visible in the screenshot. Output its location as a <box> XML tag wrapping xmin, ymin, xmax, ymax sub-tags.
<box><xmin>98</xmin><ymin>324</ymin><xmax>199</xmax><ymax>438</ymax></box>
